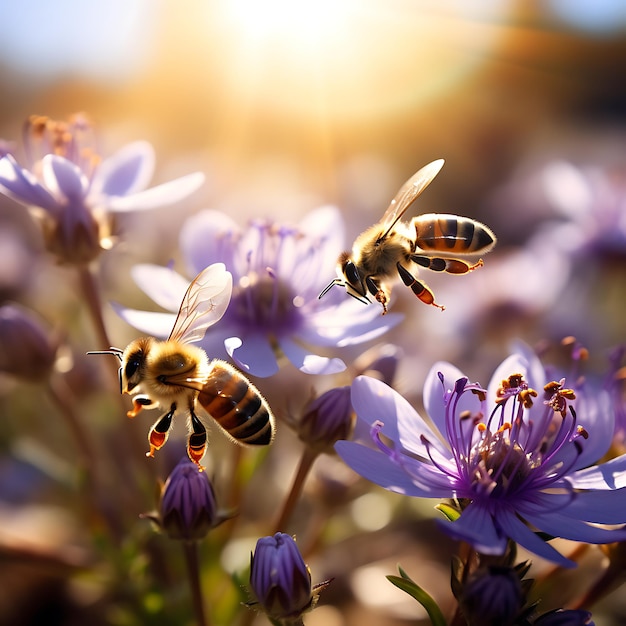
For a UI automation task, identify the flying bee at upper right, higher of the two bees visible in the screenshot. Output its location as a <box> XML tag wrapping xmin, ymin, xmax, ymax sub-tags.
<box><xmin>319</xmin><ymin>159</ymin><xmax>496</xmax><ymax>315</ymax></box>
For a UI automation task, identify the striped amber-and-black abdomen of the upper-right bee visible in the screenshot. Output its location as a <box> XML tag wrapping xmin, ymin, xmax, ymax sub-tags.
<box><xmin>411</xmin><ymin>213</ymin><xmax>496</xmax><ymax>254</ymax></box>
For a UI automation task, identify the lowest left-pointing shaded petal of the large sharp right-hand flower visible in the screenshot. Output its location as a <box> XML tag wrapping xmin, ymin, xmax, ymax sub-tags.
<box><xmin>335</xmin><ymin>441</ymin><xmax>433</xmax><ymax>498</ymax></box>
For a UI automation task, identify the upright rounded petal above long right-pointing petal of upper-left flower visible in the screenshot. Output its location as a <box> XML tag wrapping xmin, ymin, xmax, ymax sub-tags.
<box><xmin>92</xmin><ymin>141</ymin><xmax>155</xmax><ymax>196</ymax></box>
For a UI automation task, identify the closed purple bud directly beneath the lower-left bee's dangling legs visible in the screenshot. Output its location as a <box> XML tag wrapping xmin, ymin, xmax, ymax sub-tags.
<box><xmin>143</xmin><ymin>458</ymin><xmax>231</xmax><ymax>541</ymax></box>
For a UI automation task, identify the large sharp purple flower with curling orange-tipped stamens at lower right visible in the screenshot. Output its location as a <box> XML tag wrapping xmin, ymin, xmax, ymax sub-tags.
<box><xmin>335</xmin><ymin>349</ymin><xmax>626</xmax><ymax>567</ymax></box>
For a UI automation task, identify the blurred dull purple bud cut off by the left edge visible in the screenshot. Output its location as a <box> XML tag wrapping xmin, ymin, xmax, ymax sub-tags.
<box><xmin>0</xmin><ymin>304</ymin><xmax>59</xmax><ymax>381</ymax></box>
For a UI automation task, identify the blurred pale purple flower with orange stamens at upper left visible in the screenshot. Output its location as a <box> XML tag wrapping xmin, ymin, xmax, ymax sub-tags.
<box><xmin>0</xmin><ymin>115</ymin><xmax>204</xmax><ymax>263</ymax></box>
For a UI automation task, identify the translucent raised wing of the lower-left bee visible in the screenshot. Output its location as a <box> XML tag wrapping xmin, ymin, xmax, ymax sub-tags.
<box><xmin>169</xmin><ymin>263</ymin><xmax>233</xmax><ymax>343</ymax></box>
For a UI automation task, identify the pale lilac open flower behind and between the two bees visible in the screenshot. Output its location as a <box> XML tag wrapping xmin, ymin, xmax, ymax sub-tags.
<box><xmin>118</xmin><ymin>207</ymin><xmax>401</xmax><ymax>376</ymax></box>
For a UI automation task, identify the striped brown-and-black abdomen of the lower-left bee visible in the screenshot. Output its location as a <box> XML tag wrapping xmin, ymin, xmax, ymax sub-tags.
<box><xmin>198</xmin><ymin>360</ymin><xmax>274</xmax><ymax>446</ymax></box>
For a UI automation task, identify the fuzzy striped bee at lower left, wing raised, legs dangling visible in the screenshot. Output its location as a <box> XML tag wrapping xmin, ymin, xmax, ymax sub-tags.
<box><xmin>89</xmin><ymin>263</ymin><xmax>274</xmax><ymax>471</ymax></box>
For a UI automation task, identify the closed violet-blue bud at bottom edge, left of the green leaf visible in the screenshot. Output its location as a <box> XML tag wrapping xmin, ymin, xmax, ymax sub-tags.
<box><xmin>250</xmin><ymin>533</ymin><xmax>313</xmax><ymax>619</ymax></box>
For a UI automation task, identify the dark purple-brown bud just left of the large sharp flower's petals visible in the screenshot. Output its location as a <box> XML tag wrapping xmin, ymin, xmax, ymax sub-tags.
<box><xmin>297</xmin><ymin>387</ymin><xmax>356</xmax><ymax>452</ymax></box>
